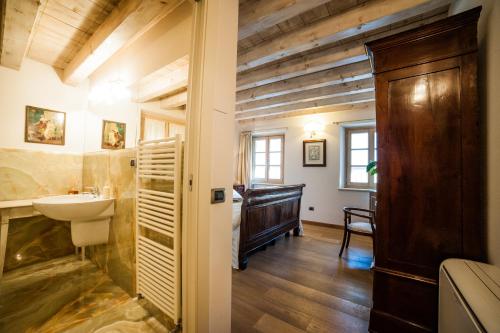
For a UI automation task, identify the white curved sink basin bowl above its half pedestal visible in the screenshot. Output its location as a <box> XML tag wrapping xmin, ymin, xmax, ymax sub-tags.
<box><xmin>33</xmin><ymin>194</ymin><xmax>114</xmax><ymax>221</ymax></box>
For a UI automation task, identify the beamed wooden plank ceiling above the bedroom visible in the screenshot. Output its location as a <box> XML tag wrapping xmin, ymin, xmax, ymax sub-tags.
<box><xmin>236</xmin><ymin>0</ymin><xmax>451</xmax><ymax>122</ymax></box>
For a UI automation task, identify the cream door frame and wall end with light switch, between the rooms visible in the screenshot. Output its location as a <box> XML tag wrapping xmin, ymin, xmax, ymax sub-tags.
<box><xmin>182</xmin><ymin>0</ymin><xmax>239</xmax><ymax>333</ymax></box>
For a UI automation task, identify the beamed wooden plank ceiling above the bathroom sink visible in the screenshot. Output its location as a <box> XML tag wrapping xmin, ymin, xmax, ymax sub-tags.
<box><xmin>0</xmin><ymin>0</ymin><xmax>184</xmax><ymax>84</ymax></box>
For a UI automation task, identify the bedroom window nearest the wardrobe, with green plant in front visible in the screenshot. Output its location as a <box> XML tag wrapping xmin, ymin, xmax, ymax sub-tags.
<box><xmin>344</xmin><ymin>127</ymin><xmax>377</xmax><ymax>189</ymax></box>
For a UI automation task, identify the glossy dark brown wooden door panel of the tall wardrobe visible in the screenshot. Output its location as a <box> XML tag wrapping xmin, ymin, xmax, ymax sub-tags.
<box><xmin>378</xmin><ymin>61</ymin><xmax>462</xmax><ymax>278</ymax></box>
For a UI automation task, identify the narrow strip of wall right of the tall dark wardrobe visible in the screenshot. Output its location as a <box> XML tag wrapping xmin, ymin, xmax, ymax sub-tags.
<box><xmin>450</xmin><ymin>0</ymin><xmax>500</xmax><ymax>266</ymax></box>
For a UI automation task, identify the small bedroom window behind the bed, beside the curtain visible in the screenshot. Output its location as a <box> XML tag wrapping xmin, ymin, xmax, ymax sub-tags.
<box><xmin>252</xmin><ymin>135</ymin><xmax>285</xmax><ymax>184</ymax></box>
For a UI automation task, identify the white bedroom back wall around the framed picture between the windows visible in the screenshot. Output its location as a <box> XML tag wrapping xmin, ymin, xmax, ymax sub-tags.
<box><xmin>238</xmin><ymin>110</ymin><xmax>375</xmax><ymax>225</ymax></box>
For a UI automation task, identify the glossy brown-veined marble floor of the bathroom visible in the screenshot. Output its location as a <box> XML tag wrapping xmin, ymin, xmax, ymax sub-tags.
<box><xmin>0</xmin><ymin>256</ymin><xmax>168</xmax><ymax>333</ymax></box>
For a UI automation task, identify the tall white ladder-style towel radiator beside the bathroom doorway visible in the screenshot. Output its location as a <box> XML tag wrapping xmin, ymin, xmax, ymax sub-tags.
<box><xmin>136</xmin><ymin>135</ymin><xmax>183</xmax><ymax>324</ymax></box>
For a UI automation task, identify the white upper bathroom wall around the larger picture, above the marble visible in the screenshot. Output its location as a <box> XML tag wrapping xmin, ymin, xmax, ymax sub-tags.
<box><xmin>0</xmin><ymin>59</ymin><xmax>88</xmax><ymax>153</ymax></box>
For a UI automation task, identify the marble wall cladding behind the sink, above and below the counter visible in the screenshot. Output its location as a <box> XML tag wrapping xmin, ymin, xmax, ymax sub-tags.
<box><xmin>0</xmin><ymin>148</ymin><xmax>83</xmax><ymax>271</ymax></box>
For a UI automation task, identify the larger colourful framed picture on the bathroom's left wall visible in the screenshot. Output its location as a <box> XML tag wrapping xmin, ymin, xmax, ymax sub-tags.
<box><xmin>24</xmin><ymin>105</ymin><xmax>66</xmax><ymax>146</ymax></box>
